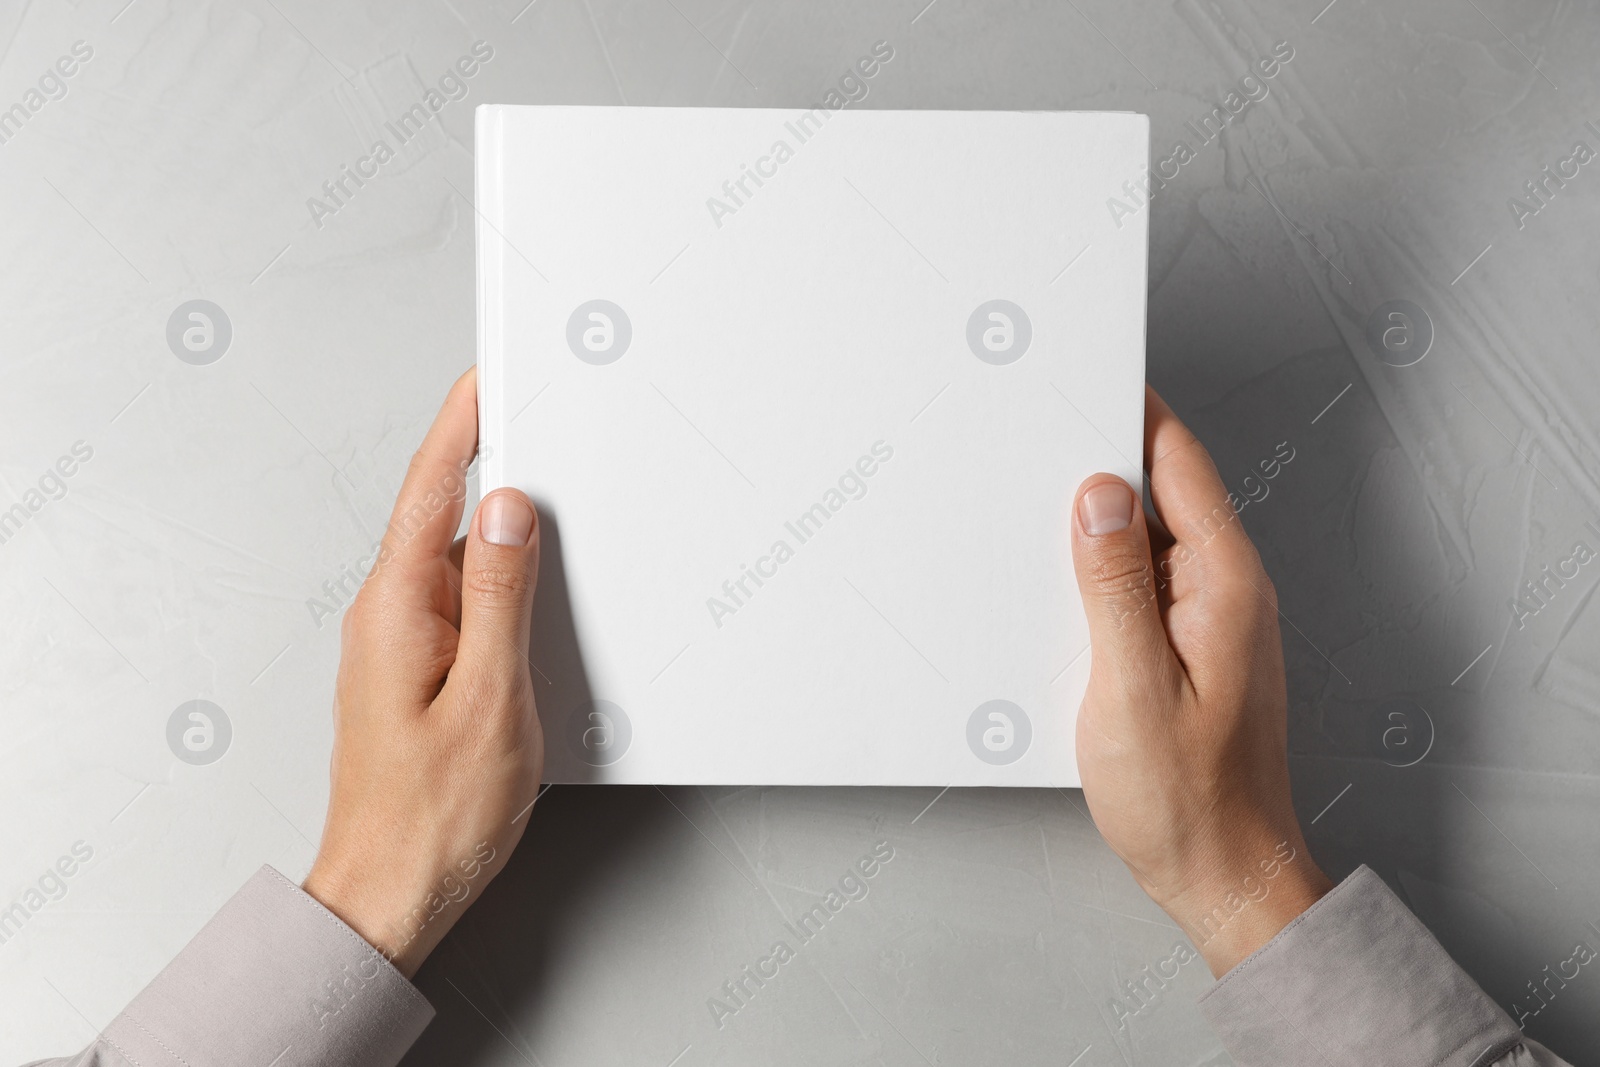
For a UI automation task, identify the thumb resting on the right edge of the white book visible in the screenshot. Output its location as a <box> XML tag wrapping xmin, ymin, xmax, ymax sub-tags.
<box><xmin>1072</xmin><ymin>474</ymin><xmax>1173</xmax><ymax>680</ymax></box>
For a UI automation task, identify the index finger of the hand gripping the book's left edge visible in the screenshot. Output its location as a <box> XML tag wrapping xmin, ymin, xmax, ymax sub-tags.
<box><xmin>379</xmin><ymin>370</ymin><xmax>478</xmax><ymax>585</ymax></box>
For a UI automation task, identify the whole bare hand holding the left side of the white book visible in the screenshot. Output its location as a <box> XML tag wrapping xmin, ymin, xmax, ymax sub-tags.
<box><xmin>304</xmin><ymin>371</ymin><xmax>544</xmax><ymax>977</ymax></box>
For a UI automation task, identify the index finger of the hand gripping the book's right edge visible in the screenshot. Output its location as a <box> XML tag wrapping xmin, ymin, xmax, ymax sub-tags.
<box><xmin>1144</xmin><ymin>387</ymin><xmax>1261</xmax><ymax>595</ymax></box>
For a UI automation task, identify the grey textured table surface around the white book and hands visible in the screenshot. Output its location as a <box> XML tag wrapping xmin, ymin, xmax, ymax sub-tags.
<box><xmin>0</xmin><ymin>0</ymin><xmax>1600</xmax><ymax>1067</ymax></box>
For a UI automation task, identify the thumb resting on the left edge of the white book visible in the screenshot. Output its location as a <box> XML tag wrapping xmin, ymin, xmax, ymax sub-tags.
<box><xmin>456</xmin><ymin>490</ymin><xmax>539</xmax><ymax>678</ymax></box>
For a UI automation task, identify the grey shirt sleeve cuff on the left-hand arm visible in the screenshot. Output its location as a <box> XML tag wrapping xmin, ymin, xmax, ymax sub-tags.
<box><xmin>34</xmin><ymin>867</ymin><xmax>434</xmax><ymax>1067</ymax></box>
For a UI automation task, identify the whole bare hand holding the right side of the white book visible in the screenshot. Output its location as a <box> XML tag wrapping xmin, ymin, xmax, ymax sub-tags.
<box><xmin>1072</xmin><ymin>390</ymin><xmax>1331</xmax><ymax>977</ymax></box>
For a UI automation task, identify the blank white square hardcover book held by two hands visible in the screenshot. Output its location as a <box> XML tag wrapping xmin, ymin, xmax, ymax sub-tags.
<box><xmin>477</xmin><ymin>106</ymin><xmax>1149</xmax><ymax>787</ymax></box>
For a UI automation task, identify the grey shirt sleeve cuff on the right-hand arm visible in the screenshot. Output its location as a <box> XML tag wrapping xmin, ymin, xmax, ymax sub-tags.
<box><xmin>1200</xmin><ymin>867</ymin><xmax>1570</xmax><ymax>1067</ymax></box>
